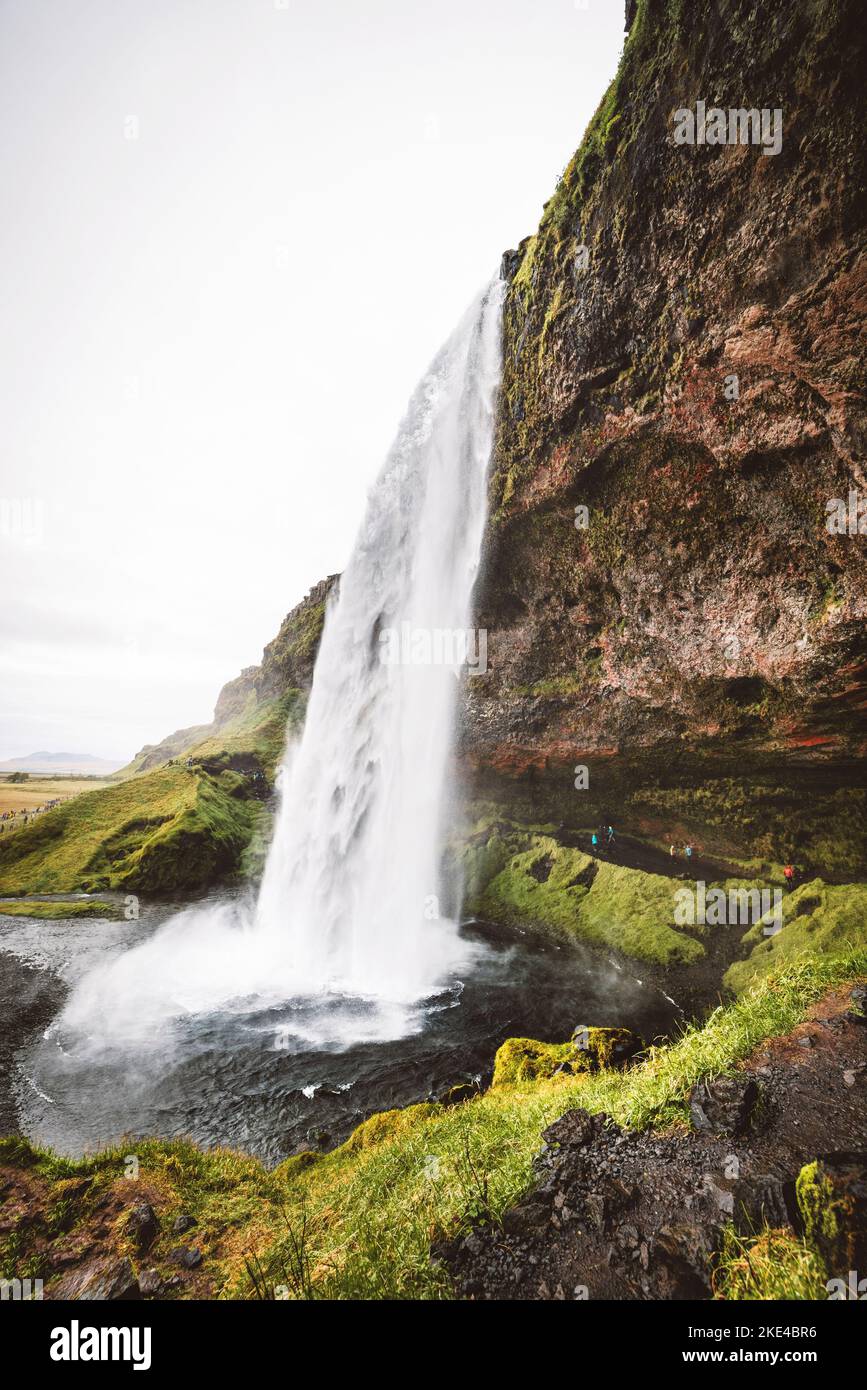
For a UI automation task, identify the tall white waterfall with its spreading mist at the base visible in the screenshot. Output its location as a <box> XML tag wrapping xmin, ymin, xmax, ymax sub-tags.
<box><xmin>63</xmin><ymin>281</ymin><xmax>503</xmax><ymax>1041</ymax></box>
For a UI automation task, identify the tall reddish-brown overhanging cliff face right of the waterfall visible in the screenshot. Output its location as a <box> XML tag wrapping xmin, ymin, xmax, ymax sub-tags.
<box><xmin>464</xmin><ymin>0</ymin><xmax>867</xmax><ymax>867</ymax></box>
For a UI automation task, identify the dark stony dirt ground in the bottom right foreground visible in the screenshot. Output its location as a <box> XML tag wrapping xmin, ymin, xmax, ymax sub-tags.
<box><xmin>434</xmin><ymin>991</ymin><xmax>867</xmax><ymax>1300</ymax></box>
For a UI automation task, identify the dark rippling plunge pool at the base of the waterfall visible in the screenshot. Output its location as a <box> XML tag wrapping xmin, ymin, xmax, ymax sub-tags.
<box><xmin>0</xmin><ymin>919</ymin><xmax>679</xmax><ymax>1163</ymax></box>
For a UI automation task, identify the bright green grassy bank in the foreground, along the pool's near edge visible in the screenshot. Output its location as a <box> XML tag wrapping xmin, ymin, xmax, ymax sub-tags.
<box><xmin>0</xmin><ymin>951</ymin><xmax>867</xmax><ymax>1298</ymax></box>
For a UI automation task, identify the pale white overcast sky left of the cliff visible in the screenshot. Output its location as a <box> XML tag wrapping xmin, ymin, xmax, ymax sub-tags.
<box><xmin>0</xmin><ymin>0</ymin><xmax>624</xmax><ymax>759</ymax></box>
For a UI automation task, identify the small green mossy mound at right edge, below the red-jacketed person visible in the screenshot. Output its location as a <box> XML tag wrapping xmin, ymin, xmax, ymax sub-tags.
<box><xmin>724</xmin><ymin>878</ymin><xmax>867</xmax><ymax>994</ymax></box>
